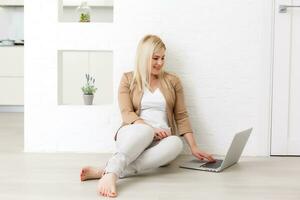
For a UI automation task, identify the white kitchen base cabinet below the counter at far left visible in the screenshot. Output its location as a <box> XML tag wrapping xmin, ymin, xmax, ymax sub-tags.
<box><xmin>0</xmin><ymin>47</ymin><xmax>24</xmax><ymax>105</ymax></box>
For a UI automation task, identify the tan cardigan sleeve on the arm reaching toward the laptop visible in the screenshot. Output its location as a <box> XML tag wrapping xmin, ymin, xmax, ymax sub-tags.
<box><xmin>174</xmin><ymin>77</ymin><xmax>193</xmax><ymax>136</ymax></box>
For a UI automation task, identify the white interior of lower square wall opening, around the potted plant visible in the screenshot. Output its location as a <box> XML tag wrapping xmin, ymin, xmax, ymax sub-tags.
<box><xmin>58</xmin><ymin>51</ymin><xmax>113</xmax><ymax>105</ymax></box>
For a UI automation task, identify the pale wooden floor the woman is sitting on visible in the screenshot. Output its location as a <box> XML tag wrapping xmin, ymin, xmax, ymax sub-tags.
<box><xmin>0</xmin><ymin>113</ymin><xmax>300</xmax><ymax>200</ymax></box>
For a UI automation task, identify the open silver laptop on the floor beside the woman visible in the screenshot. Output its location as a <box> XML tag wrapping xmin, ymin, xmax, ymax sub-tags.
<box><xmin>179</xmin><ymin>128</ymin><xmax>252</xmax><ymax>172</ymax></box>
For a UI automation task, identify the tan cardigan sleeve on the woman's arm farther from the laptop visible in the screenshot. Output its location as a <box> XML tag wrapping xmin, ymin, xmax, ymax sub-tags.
<box><xmin>118</xmin><ymin>73</ymin><xmax>141</xmax><ymax>124</ymax></box>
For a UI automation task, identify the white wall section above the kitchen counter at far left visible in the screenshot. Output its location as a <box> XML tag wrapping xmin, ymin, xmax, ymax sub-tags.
<box><xmin>0</xmin><ymin>7</ymin><xmax>24</xmax><ymax>40</ymax></box>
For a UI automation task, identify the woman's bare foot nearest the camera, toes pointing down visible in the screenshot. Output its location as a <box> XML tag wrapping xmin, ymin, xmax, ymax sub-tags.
<box><xmin>97</xmin><ymin>173</ymin><xmax>117</xmax><ymax>197</ymax></box>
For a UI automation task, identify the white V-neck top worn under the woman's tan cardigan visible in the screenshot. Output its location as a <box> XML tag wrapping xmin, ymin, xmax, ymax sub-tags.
<box><xmin>140</xmin><ymin>88</ymin><xmax>170</xmax><ymax>130</ymax></box>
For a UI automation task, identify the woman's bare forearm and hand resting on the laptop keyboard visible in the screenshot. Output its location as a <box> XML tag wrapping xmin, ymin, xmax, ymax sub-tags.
<box><xmin>183</xmin><ymin>132</ymin><xmax>215</xmax><ymax>162</ymax></box>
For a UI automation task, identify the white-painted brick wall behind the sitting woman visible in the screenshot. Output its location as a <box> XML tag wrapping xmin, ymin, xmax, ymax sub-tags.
<box><xmin>25</xmin><ymin>0</ymin><xmax>272</xmax><ymax>155</ymax></box>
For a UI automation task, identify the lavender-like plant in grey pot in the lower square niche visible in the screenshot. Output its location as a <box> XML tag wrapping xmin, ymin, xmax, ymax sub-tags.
<box><xmin>81</xmin><ymin>74</ymin><xmax>97</xmax><ymax>105</ymax></box>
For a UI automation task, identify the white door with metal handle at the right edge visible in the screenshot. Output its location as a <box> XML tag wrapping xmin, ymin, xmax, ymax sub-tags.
<box><xmin>271</xmin><ymin>0</ymin><xmax>300</xmax><ymax>155</ymax></box>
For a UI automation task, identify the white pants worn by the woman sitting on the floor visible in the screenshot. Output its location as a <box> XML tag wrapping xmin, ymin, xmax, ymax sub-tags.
<box><xmin>105</xmin><ymin>124</ymin><xmax>183</xmax><ymax>178</ymax></box>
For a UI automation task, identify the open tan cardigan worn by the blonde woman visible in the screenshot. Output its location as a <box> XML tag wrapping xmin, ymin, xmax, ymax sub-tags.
<box><xmin>115</xmin><ymin>72</ymin><xmax>193</xmax><ymax>139</ymax></box>
